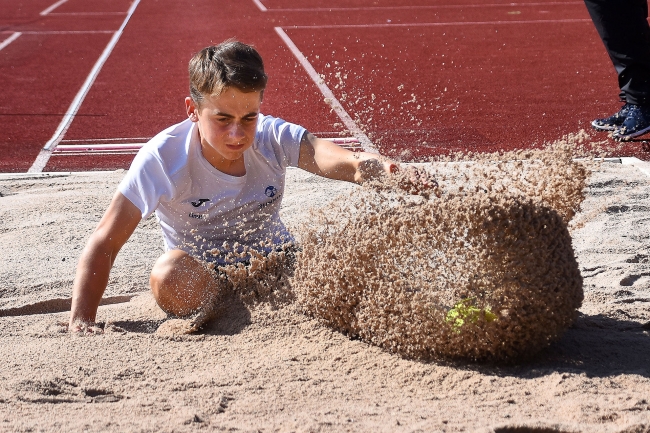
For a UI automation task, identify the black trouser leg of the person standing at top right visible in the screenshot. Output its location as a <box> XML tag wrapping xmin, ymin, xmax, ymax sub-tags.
<box><xmin>585</xmin><ymin>0</ymin><xmax>650</xmax><ymax>105</ymax></box>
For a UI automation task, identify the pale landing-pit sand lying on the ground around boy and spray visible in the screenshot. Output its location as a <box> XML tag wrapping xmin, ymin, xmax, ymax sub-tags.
<box><xmin>0</xmin><ymin>163</ymin><xmax>650</xmax><ymax>433</ymax></box>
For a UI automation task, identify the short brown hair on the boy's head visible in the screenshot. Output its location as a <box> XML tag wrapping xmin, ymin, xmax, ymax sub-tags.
<box><xmin>189</xmin><ymin>40</ymin><xmax>268</xmax><ymax>103</ymax></box>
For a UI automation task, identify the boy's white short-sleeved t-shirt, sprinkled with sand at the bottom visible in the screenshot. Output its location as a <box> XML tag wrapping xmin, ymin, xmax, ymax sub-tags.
<box><xmin>118</xmin><ymin>114</ymin><xmax>305</xmax><ymax>263</ymax></box>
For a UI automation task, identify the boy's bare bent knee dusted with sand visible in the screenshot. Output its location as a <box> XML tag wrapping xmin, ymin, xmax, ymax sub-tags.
<box><xmin>149</xmin><ymin>250</ymin><xmax>215</xmax><ymax>317</ymax></box>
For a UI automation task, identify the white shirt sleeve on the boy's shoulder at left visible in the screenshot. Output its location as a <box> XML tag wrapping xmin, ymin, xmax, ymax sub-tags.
<box><xmin>117</xmin><ymin>148</ymin><xmax>174</xmax><ymax>219</ymax></box>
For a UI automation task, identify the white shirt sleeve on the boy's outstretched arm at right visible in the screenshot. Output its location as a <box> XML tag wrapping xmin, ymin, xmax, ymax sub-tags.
<box><xmin>260</xmin><ymin>116</ymin><xmax>307</xmax><ymax>168</ymax></box>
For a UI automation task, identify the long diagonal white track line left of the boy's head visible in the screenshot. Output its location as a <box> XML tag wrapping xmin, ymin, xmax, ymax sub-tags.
<box><xmin>27</xmin><ymin>0</ymin><xmax>140</xmax><ymax>173</ymax></box>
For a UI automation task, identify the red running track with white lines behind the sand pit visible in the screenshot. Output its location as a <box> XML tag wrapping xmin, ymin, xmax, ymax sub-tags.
<box><xmin>0</xmin><ymin>0</ymin><xmax>650</xmax><ymax>172</ymax></box>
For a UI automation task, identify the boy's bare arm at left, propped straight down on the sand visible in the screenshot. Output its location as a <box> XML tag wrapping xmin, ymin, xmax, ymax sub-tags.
<box><xmin>68</xmin><ymin>192</ymin><xmax>142</xmax><ymax>332</ymax></box>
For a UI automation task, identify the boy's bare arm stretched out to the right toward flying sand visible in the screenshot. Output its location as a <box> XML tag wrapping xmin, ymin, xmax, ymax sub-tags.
<box><xmin>298</xmin><ymin>132</ymin><xmax>437</xmax><ymax>189</ymax></box>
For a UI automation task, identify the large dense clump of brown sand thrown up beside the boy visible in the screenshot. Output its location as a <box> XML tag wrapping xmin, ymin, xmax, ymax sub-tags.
<box><xmin>293</xmin><ymin>143</ymin><xmax>587</xmax><ymax>360</ymax></box>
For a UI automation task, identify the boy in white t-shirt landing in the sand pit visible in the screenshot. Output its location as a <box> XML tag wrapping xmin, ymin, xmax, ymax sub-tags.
<box><xmin>69</xmin><ymin>41</ymin><xmax>429</xmax><ymax>332</ymax></box>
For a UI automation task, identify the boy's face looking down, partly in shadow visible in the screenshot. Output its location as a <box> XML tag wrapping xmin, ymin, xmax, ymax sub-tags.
<box><xmin>185</xmin><ymin>87</ymin><xmax>262</xmax><ymax>164</ymax></box>
